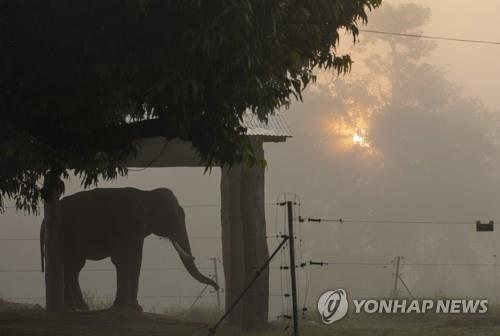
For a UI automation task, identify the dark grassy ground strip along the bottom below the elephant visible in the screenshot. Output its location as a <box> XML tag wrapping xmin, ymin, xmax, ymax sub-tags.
<box><xmin>0</xmin><ymin>300</ymin><xmax>500</xmax><ymax>336</ymax></box>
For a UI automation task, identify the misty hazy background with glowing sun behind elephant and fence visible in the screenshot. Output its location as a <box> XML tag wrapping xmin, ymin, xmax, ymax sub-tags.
<box><xmin>0</xmin><ymin>0</ymin><xmax>500</xmax><ymax>317</ymax></box>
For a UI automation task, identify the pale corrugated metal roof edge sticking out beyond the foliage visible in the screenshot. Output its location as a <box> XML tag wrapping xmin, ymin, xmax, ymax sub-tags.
<box><xmin>242</xmin><ymin>112</ymin><xmax>292</xmax><ymax>138</ymax></box>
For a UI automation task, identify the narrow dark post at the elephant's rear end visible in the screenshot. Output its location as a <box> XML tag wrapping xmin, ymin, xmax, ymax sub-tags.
<box><xmin>44</xmin><ymin>191</ymin><xmax>64</xmax><ymax>311</ymax></box>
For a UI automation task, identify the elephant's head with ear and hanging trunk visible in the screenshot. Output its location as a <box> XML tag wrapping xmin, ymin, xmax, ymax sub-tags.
<box><xmin>134</xmin><ymin>188</ymin><xmax>219</xmax><ymax>289</ymax></box>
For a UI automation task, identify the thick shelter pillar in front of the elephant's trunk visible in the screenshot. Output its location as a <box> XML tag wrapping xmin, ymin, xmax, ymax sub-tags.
<box><xmin>221</xmin><ymin>142</ymin><xmax>269</xmax><ymax>331</ymax></box>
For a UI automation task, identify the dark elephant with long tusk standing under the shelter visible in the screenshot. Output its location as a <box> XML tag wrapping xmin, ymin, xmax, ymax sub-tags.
<box><xmin>40</xmin><ymin>188</ymin><xmax>218</xmax><ymax>311</ymax></box>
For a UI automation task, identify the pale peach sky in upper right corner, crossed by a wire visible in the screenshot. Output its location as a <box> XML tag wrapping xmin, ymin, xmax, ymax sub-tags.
<box><xmin>384</xmin><ymin>0</ymin><xmax>500</xmax><ymax>110</ymax></box>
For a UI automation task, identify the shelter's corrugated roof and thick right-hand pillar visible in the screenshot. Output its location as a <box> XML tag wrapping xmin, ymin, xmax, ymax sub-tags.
<box><xmin>126</xmin><ymin>113</ymin><xmax>291</xmax><ymax>330</ymax></box>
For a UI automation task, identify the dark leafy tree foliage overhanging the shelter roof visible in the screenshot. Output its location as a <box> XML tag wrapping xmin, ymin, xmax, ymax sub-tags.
<box><xmin>0</xmin><ymin>0</ymin><xmax>381</xmax><ymax>209</ymax></box>
